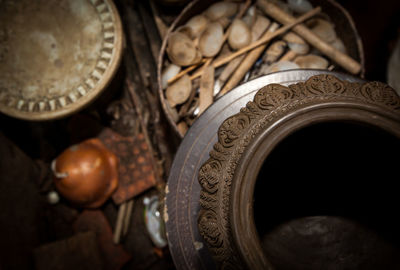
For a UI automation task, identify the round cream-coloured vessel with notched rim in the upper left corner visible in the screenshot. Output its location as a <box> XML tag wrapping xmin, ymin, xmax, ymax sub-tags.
<box><xmin>0</xmin><ymin>0</ymin><xmax>123</xmax><ymax>120</ymax></box>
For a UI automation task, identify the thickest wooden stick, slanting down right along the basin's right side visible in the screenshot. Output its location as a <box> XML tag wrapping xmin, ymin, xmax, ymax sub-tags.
<box><xmin>257</xmin><ymin>0</ymin><xmax>361</xmax><ymax>74</ymax></box>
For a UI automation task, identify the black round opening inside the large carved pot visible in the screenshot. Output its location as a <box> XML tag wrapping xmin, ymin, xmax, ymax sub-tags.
<box><xmin>254</xmin><ymin>122</ymin><xmax>400</xmax><ymax>269</ymax></box>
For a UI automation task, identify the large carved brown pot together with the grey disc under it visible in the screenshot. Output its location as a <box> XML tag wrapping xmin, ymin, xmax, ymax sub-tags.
<box><xmin>164</xmin><ymin>70</ymin><xmax>400</xmax><ymax>269</ymax></box>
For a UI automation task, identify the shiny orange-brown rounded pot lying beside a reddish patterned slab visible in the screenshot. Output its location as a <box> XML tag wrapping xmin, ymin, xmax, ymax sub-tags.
<box><xmin>52</xmin><ymin>139</ymin><xmax>118</xmax><ymax>208</ymax></box>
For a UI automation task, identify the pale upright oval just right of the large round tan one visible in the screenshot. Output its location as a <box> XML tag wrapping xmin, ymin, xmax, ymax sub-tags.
<box><xmin>198</xmin><ymin>22</ymin><xmax>224</xmax><ymax>57</ymax></box>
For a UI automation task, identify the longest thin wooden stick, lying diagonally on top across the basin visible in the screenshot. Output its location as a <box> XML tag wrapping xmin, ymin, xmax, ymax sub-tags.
<box><xmin>190</xmin><ymin>7</ymin><xmax>321</xmax><ymax>80</ymax></box>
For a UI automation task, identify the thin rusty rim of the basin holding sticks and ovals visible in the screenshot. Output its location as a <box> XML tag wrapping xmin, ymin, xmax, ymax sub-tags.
<box><xmin>157</xmin><ymin>0</ymin><xmax>365</xmax><ymax>138</ymax></box>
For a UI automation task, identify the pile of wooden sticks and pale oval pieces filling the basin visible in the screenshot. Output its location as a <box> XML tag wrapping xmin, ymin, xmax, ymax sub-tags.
<box><xmin>161</xmin><ymin>0</ymin><xmax>362</xmax><ymax>136</ymax></box>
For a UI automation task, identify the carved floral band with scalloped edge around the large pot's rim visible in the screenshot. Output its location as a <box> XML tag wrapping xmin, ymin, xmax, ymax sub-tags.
<box><xmin>198</xmin><ymin>74</ymin><xmax>400</xmax><ymax>269</ymax></box>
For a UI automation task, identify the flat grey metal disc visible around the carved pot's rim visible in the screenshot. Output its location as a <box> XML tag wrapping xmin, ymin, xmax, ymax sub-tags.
<box><xmin>164</xmin><ymin>70</ymin><xmax>362</xmax><ymax>269</ymax></box>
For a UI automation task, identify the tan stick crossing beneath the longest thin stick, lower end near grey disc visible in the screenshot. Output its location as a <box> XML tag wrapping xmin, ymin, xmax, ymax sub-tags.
<box><xmin>220</xmin><ymin>23</ymin><xmax>278</xmax><ymax>95</ymax></box>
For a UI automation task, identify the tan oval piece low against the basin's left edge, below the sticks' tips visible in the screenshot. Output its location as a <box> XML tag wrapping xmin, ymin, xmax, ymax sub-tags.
<box><xmin>165</xmin><ymin>75</ymin><xmax>192</xmax><ymax>108</ymax></box>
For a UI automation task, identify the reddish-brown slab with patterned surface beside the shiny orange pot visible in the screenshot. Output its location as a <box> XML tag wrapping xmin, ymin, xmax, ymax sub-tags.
<box><xmin>98</xmin><ymin>129</ymin><xmax>156</xmax><ymax>204</ymax></box>
